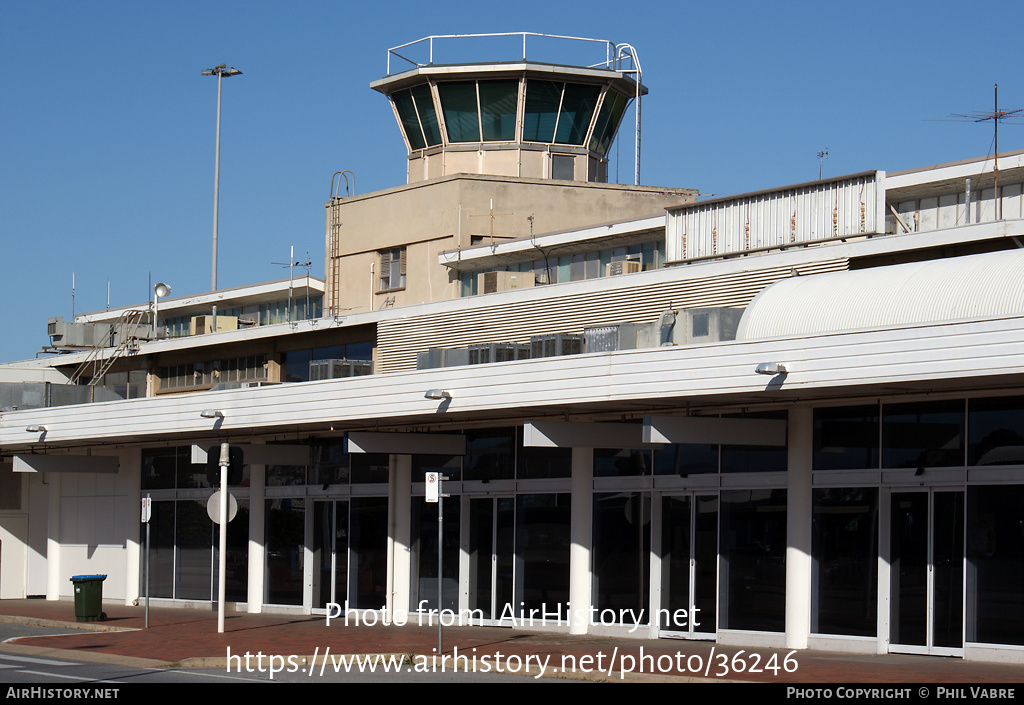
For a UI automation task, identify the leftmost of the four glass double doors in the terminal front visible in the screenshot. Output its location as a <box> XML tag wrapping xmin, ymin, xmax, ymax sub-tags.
<box><xmin>312</xmin><ymin>500</ymin><xmax>348</xmax><ymax>612</ymax></box>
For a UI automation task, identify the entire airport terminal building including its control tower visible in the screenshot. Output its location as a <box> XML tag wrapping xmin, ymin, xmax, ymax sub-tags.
<box><xmin>0</xmin><ymin>35</ymin><xmax>1024</xmax><ymax>662</ymax></box>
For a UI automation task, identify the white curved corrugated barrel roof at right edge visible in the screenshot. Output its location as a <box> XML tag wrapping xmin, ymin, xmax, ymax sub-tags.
<box><xmin>736</xmin><ymin>249</ymin><xmax>1024</xmax><ymax>340</ymax></box>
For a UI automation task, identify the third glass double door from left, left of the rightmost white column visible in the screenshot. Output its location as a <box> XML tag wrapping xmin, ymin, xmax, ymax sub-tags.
<box><xmin>659</xmin><ymin>494</ymin><xmax>718</xmax><ymax>638</ymax></box>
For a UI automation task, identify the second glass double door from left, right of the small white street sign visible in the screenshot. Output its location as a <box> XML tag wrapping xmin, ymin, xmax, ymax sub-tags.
<box><xmin>468</xmin><ymin>497</ymin><xmax>516</xmax><ymax>625</ymax></box>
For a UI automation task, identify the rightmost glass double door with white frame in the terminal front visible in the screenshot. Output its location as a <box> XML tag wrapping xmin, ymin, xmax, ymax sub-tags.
<box><xmin>889</xmin><ymin>490</ymin><xmax>964</xmax><ymax>656</ymax></box>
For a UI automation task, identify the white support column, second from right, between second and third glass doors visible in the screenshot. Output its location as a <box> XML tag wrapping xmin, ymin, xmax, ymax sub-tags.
<box><xmin>569</xmin><ymin>448</ymin><xmax>594</xmax><ymax>634</ymax></box>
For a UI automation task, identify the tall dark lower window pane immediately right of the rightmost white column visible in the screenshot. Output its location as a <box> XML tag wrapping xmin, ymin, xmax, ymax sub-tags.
<box><xmin>811</xmin><ymin>487</ymin><xmax>879</xmax><ymax>636</ymax></box>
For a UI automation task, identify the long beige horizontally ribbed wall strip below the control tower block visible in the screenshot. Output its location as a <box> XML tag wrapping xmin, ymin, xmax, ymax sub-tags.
<box><xmin>375</xmin><ymin>257</ymin><xmax>848</xmax><ymax>373</ymax></box>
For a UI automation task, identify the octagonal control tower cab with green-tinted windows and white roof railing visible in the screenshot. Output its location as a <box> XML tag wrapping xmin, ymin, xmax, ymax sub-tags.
<box><xmin>370</xmin><ymin>33</ymin><xmax>646</xmax><ymax>183</ymax></box>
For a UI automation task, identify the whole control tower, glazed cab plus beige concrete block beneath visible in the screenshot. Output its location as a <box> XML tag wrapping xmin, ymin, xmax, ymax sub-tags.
<box><xmin>324</xmin><ymin>33</ymin><xmax>697</xmax><ymax>313</ymax></box>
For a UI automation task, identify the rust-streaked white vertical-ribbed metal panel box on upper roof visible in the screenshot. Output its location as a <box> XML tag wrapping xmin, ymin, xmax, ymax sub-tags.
<box><xmin>666</xmin><ymin>171</ymin><xmax>885</xmax><ymax>261</ymax></box>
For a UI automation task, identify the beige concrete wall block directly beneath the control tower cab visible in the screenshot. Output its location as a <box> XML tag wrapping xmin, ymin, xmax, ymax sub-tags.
<box><xmin>325</xmin><ymin>174</ymin><xmax>695</xmax><ymax>313</ymax></box>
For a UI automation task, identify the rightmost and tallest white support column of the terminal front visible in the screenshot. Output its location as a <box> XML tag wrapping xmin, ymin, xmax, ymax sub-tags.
<box><xmin>785</xmin><ymin>407</ymin><xmax>814</xmax><ymax>649</ymax></box>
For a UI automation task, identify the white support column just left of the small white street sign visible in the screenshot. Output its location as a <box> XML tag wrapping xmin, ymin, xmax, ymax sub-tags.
<box><xmin>387</xmin><ymin>455</ymin><xmax>413</xmax><ymax>620</ymax></box>
